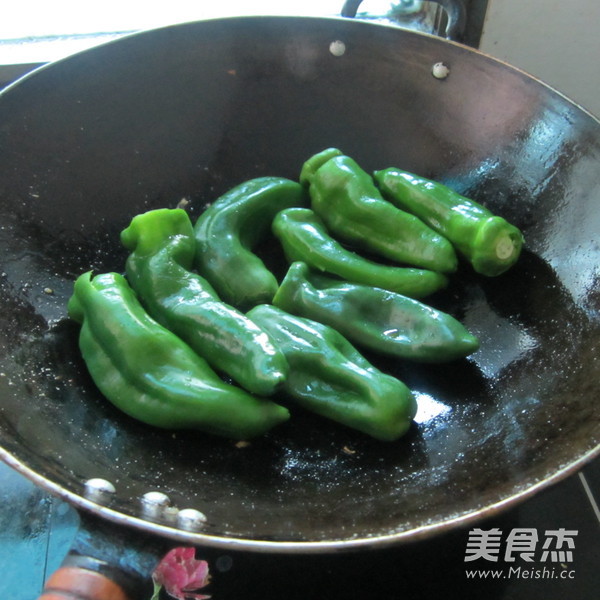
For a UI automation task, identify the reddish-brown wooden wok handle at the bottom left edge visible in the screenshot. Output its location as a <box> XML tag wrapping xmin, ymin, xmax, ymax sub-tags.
<box><xmin>39</xmin><ymin>566</ymin><xmax>130</xmax><ymax>600</ymax></box>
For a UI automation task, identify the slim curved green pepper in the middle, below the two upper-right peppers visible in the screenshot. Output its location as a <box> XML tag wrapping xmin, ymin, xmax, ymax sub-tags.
<box><xmin>273</xmin><ymin>208</ymin><xmax>448</xmax><ymax>298</ymax></box>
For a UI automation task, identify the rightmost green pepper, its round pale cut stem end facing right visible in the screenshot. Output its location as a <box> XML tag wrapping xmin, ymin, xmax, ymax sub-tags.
<box><xmin>375</xmin><ymin>168</ymin><xmax>523</xmax><ymax>276</ymax></box>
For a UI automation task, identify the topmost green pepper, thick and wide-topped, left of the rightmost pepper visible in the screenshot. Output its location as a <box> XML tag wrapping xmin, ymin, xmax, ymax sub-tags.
<box><xmin>303</xmin><ymin>151</ymin><xmax>457</xmax><ymax>273</ymax></box>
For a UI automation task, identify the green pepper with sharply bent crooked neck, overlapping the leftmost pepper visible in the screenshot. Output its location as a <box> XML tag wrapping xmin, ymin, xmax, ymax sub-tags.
<box><xmin>121</xmin><ymin>208</ymin><xmax>287</xmax><ymax>395</ymax></box>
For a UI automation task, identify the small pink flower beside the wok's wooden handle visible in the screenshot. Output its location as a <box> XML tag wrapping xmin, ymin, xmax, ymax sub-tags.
<box><xmin>152</xmin><ymin>547</ymin><xmax>210</xmax><ymax>600</ymax></box>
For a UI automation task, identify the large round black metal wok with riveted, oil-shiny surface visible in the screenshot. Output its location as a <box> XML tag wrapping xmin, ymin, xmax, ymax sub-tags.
<box><xmin>0</xmin><ymin>12</ymin><xmax>600</xmax><ymax>596</ymax></box>
